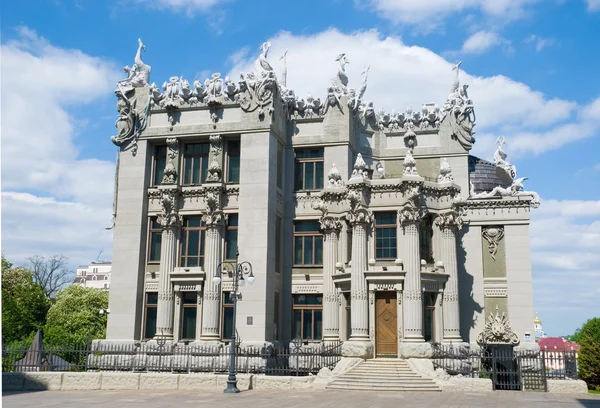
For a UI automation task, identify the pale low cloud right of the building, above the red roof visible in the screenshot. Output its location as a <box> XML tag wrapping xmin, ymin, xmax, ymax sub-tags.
<box><xmin>531</xmin><ymin>200</ymin><xmax>600</xmax><ymax>335</ymax></box>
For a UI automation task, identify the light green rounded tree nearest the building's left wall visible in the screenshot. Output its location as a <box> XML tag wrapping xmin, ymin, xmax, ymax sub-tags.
<box><xmin>44</xmin><ymin>285</ymin><xmax>108</xmax><ymax>347</ymax></box>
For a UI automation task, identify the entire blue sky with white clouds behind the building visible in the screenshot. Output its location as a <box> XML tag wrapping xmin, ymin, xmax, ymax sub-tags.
<box><xmin>1</xmin><ymin>0</ymin><xmax>600</xmax><ymax>335</ymax></box>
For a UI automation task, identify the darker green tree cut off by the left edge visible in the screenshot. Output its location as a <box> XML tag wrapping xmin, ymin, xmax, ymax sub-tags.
<box><xmin>2</xmin><ymin>257</ymin><xmax>50</xmax><ymax>343</ymax></box>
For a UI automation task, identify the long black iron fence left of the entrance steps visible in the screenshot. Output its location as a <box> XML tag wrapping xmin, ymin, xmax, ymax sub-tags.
<box><xmin>2</xmin><ymin>342</ymin><xmax>341</xmax><ymax>376</ymax></box>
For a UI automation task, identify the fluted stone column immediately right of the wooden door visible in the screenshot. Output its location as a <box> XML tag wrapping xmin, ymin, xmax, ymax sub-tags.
<box><xmin>403</xmin><ymin>217</ymin><xmax>424</xmax><ymax>342</ymax></box>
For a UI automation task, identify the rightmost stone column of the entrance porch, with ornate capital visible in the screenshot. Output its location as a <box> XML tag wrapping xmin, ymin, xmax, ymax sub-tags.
<box><xmin>436</xmin><ymin>214</ymin><xmax>462</xmax><ymax>342</ymax></box>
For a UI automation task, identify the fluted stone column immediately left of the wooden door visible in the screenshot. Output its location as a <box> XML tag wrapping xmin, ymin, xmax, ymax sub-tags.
<box><xmin>350</xmin><ymin>219</ymin><xmax>369</xmax><ymax>341</ymax></box>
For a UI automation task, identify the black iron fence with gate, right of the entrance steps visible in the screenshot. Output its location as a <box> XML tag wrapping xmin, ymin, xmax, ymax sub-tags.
<box><xmin>432</xmin><ymin>344</ymin><xmax>577</xmax><ymax>391</ymax></box>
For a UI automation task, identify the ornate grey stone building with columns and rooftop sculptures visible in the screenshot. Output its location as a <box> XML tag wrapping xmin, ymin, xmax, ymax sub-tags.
<box><xmin>107</xmin><ymin>41</ymin><xmax>538</xmax><ymax>357</ymax></box>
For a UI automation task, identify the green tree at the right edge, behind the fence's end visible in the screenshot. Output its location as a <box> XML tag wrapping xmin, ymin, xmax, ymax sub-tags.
<box><xmin>573</xmin><ymin>317</ymin><xmax>600</xmax><ymax>390</ymax></box>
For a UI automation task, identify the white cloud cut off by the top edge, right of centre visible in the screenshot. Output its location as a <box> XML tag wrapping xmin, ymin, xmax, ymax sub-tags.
<box><xmin>364</xmin><ymin>0</ymin><xmax>540</xmax><ymax>28</ymax></box>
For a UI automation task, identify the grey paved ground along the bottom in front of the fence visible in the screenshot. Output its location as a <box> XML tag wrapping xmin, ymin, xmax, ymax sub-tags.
<box><xmin>2</xmin><ymin>390</ymin><xmax>600</xmax><ymax>408</ymax></box>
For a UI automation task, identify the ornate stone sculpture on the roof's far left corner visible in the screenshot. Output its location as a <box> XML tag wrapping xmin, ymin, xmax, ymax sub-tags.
<box><xmin>110</xmin><ymin>39</ymin><xmax>151</xmax><ymax>156</ymax></box>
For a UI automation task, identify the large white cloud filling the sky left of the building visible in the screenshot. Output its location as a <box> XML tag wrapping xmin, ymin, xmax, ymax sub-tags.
<box><xmin>1</xmin><ymin>27</ymin><xmax>120</xmax><ymax>263</ymax></box>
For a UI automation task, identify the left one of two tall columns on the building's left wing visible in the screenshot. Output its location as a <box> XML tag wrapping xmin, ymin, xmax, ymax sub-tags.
<box><xmin>154</xmin><ymin>222</ymin><xmax>179</xmax><ymax>339</ymax></box>
